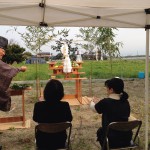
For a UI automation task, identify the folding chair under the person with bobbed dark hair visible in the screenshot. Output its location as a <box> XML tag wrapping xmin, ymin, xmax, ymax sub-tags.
<box><xmin>35</xmin><ymin>122</ymin><xmax>72</xmax><ymax>150</ymax></box>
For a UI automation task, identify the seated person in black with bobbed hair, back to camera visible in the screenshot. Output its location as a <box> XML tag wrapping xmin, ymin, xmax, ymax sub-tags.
<box><xmin>33</xmin><ymin>79</ymin><xmax>72</xmax><ymax>150</ymax></box>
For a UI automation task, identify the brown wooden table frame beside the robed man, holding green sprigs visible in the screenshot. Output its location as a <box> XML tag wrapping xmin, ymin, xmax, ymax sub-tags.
<box><xmin>0</xmin><ymin>89</ymin><xmax>31</xmax><ymax>127</ymax></box>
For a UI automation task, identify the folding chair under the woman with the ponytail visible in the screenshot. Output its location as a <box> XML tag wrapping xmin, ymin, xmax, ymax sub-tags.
<box><xmin>102</xmin><ymin>120</ymin><xmax>142</xmax><ymax>150</ymax></box>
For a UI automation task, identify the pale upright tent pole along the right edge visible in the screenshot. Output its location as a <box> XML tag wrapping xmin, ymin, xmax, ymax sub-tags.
<box><xmin>145</xmin><ymin>29</ymin><xmax>149</xmax><ymax>150</ymax></box>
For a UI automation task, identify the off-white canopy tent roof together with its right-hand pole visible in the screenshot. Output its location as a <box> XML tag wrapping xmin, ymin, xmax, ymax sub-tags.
<box><xmin>0</xmin><ymin>0</ymin><xmax>150</xmax><ymax>150</ymax></box>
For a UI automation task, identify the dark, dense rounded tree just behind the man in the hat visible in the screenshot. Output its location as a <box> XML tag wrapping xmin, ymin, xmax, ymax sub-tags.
<box><xmin>3</xmin><ymin>43</ymin><xmax>25</xmax><ymax>64</ymax></box>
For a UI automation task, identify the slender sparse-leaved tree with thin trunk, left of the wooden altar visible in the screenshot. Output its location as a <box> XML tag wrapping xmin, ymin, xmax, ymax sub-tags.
<box><xmin>12</xmin><ymin>26</ymin><xmax>57</xmax><ymax>98</ymax></box>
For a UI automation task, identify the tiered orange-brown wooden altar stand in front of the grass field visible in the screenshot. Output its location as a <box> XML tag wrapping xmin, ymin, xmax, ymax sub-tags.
<box><xmin>49</xmin><ymin>62</ymin><xmax>87</xmax><ymax>104</ymax></box>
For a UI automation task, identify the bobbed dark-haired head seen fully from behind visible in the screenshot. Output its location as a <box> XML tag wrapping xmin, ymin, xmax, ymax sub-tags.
<box><xmin>44</xmin><ymin>79</ymin><xmax>64</xmax><ymax>102</ymax></box>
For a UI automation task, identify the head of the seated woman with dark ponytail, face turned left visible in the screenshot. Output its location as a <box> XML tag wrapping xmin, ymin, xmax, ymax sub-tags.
<box><xmin>105</xmin><ymin>77</ymin><xmax>129</xmax><ymax>100</ymax></box>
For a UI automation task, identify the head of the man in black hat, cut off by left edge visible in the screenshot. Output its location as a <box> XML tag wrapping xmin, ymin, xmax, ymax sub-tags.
<box><xmin>0</xmin><ymin>36</ymin><xmax>8</xmax><ymax>59</ymax></box>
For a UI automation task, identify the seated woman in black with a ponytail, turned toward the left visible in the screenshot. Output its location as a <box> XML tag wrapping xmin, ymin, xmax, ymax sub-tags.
<box><xmin>90</xmin><ymin>78</ymin><xmax>132</xmax><ymax>148</ymax></box>
